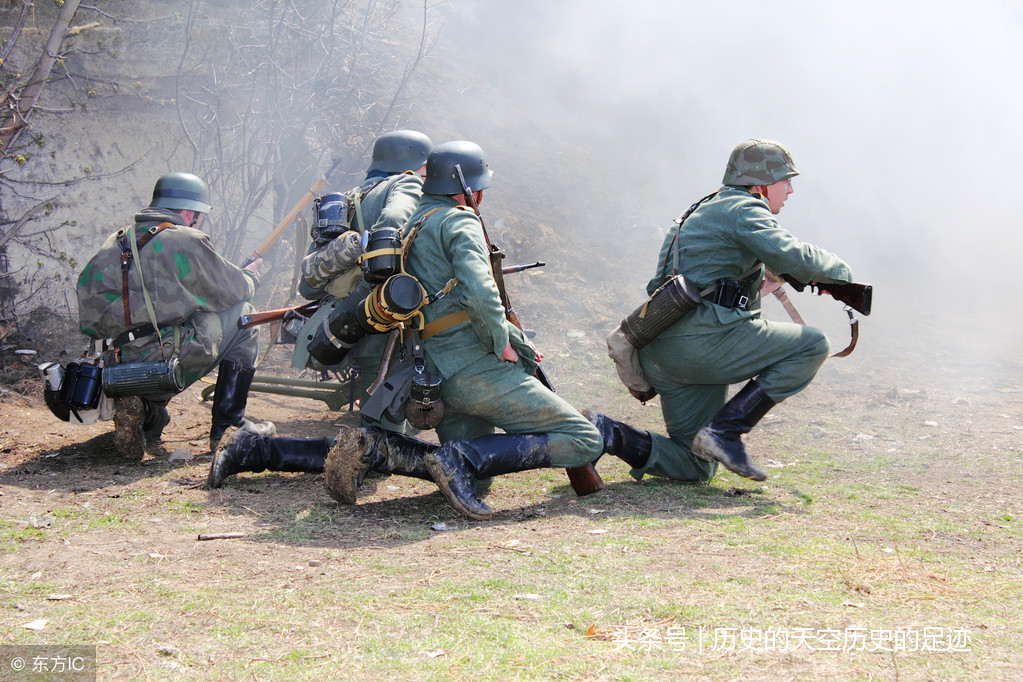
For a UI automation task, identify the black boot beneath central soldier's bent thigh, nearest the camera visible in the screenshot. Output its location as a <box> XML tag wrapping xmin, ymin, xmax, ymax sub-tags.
<box><xmin>422</xmin><ymin>434</ymin><xmax>550</xmax><ymax>520</ymax></box>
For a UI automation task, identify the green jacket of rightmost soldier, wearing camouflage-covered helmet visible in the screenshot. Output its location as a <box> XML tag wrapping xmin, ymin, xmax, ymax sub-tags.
<box><xmin>647</xmin><ymin>186</ymin><xmax>852</xmax><ymax>336</ymax></box>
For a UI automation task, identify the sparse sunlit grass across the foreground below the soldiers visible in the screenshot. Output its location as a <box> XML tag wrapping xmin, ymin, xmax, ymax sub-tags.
<box><xmin>0</xmin><ymin>361</ymin><xmax>1023</xmax><ymax>680</ymax></box>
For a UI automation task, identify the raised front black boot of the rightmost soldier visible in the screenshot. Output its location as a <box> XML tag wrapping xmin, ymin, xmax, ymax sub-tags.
<box><xmin>693</xmin><ymin>379</ymin><xmax>776</xmax><ymax>481</ymax></box>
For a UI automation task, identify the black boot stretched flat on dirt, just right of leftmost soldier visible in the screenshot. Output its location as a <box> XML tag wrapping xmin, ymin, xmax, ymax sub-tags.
<box><xmin>206</xmin><ymin>435</ymin><xmax>330</xmax><ymax>490</ymax></box>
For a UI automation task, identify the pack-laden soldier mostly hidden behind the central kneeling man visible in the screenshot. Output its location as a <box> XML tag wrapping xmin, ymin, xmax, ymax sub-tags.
<box><xmin>207</xmin><ymin>130</ymin><xmax>433</xmax><ymax>489</ymax></box>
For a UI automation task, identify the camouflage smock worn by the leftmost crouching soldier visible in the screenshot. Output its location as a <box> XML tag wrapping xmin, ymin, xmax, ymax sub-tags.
<box><xmin>76</xmin><ymin>209</ymin><xmax>257</xmax><ymax>338</ymax></box>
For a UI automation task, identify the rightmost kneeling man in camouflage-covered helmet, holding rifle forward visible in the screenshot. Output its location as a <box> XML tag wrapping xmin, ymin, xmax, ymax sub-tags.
<box><xmin>589</xmin><ymin>139</ymin><xmax>852</xmax><ymax>482</ymax></box>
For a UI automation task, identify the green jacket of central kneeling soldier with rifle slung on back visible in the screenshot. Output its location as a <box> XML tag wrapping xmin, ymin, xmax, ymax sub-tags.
<box><xmin>405</xmin><ymin>194</ymin><xmax>536</xmax><ymax>378</ymax></box>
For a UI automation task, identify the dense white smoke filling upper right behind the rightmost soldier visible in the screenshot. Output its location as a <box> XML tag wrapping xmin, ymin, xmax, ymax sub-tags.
<box><xmin>441</xmin><ymin>0</ymin><xmax>1023</xmax><ymax>386</ymax></box>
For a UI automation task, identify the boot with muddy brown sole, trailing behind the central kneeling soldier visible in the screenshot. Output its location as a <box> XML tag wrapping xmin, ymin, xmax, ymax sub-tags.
<box><xmin>323</xmin><ymin>426</ymin><xmax>438</xmax><ymax>504</ymax></box>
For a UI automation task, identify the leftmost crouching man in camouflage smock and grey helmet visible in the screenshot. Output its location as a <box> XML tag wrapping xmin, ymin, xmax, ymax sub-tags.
<box><xmin>77</xmin><ymin>173</ymin><xmax>273</xmax><ymax>458</ymax></box>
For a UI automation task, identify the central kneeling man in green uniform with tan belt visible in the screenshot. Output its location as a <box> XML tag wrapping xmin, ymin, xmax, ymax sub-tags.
<box><xmin>326</xmin><ymin>141</ymin><xmax>602</xmax><ymax>519</ymax></box>
